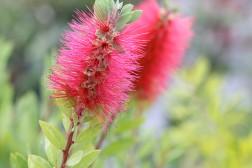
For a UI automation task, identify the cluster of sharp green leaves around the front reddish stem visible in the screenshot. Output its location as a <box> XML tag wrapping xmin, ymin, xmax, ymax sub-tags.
<box><xmin>25</xmin><ymin>112</ymin><xmax>101</xmax><ymax>168</ymax></box>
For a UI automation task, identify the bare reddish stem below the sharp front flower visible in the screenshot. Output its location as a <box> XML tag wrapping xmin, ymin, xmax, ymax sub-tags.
<box><xmin>61</xmin><ymin>118</ymin><xmax>75</xmax><ymax>168</ymax></box>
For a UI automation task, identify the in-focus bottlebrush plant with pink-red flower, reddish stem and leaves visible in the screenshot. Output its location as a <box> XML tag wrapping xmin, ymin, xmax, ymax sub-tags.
<box><xmin>25</xmin><ymin>0</ymin><xmax>142</xmax><ymax>168</ymax></box>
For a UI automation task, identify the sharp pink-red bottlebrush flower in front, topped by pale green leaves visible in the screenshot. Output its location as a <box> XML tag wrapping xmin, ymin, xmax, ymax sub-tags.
<box><xmin>49</xmin><ymin>0</ymin><xmax>142</xmax><ymax>121</ymax></box>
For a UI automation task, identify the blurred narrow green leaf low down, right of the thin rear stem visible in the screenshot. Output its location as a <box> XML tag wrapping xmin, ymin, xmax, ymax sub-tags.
<box><xmin>102</xmin><ymin>138</ymin><xmax>135</xmax><ymax>157</ymax></box>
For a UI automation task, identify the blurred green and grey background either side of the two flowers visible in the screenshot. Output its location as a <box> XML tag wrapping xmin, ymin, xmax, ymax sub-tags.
<box><xmin>0</xmin><ymin>0</ymin><xmax>252</xmax><ymax>168</ymax></box>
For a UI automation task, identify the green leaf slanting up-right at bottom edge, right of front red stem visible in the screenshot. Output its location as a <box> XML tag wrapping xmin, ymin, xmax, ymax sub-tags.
<box><xmin>73</xmin><ymin>150</ymin><xmax>100</xmax><ymax>168</ymax></box>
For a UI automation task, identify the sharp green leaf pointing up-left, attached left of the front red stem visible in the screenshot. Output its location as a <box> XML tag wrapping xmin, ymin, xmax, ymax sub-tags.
<box><xmin>39</xmin><ymin>121</ymin><xmax>66</xmax><ymax>150</ymax></box>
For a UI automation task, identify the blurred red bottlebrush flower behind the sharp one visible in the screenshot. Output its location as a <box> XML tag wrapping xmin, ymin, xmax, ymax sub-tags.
<box><xmin>136</xmin><ymin>0</ymin><xmax>193</xmax><ymax>100</ymax></box>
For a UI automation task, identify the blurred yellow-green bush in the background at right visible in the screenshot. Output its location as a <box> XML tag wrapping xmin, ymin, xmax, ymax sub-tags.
<box><xmin>132</xmin><ymin>59</ymin><xmax>251</xmax><ymax>168</ymax></box>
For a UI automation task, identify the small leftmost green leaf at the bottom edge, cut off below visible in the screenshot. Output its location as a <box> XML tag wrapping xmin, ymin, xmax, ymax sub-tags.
<box><xmin>10</xmin><ymin>153</ymin><xmax>27</xmax><ymax>168</ymax></box>
